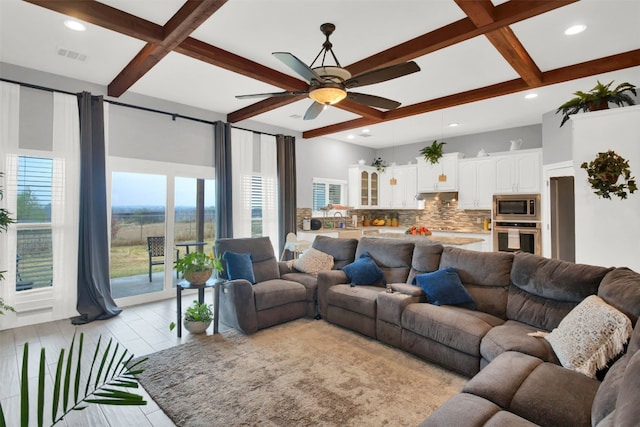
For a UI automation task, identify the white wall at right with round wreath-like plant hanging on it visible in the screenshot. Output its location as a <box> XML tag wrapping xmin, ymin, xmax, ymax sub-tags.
<box><xmin>565</xmin><ymin>106</ymin><xmax>640</xmax><ymax>272</ymax></box>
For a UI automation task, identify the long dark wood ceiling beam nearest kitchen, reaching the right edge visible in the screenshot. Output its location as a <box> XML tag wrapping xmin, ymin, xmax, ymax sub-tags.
<box><xmin>302</xmin><ymin>49</ymin><xmax>640</xmax><ymax>138</ymax></box>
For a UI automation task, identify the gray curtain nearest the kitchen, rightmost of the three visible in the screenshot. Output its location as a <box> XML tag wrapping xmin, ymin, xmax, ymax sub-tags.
<box><xmin>276</xmin><ymin>135</ymin><xmax>298</xmax><ymax>255</ymax></box>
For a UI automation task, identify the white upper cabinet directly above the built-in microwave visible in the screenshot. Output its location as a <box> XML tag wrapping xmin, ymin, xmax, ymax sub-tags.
<box><xmin>495</xmin><ymin>149</ymin><xmax>542</xmax><ymax>193</ymax></box>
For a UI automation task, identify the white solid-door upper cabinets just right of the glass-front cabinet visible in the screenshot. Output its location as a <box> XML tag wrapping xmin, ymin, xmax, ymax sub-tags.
<box><xmin>378</xmin><ymin>165</ymin><xmax>424</xmax><ymax>209</ymax></box>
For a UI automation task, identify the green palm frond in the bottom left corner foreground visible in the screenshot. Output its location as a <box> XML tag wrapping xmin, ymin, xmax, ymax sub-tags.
<box><xmin>0</xmin><ymin>333</ymin><xmax>147</xmax><ymax>427</ymax></box>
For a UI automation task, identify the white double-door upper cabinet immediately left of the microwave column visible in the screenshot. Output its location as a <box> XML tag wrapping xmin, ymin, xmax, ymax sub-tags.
<box><xmin>458</xmin><ymin>157</ymin><xmax>496</xmax><ymax>209</ymax></box>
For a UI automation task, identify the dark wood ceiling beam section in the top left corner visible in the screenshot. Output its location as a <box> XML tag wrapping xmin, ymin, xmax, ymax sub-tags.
<box><xmin>24</xmin><ymin>0</ymin><xmax>164</xmax><ymax>43</ymax></box>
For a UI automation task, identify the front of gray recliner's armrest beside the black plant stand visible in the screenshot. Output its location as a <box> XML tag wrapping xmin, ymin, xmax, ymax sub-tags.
<box><xmin>215</xmin><ymin>279</ymin><xmax>258</xmax><ymax>334</ymax></box>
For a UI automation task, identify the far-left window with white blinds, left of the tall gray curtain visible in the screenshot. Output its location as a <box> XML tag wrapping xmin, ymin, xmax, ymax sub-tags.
<box><xmin>16</xmin><ymin>156</ymin><xmax>53</xmax><ymax>291</ymax></box>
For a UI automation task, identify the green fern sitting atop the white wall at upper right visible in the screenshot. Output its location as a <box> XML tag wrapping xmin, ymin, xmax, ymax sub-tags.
<box><xmin>556</xmin><ymin>80</ymin><xmax>636</xmax><ymax>127</ymax></box>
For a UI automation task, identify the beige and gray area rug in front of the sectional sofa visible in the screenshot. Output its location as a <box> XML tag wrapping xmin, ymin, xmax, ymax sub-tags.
<box><xmin>140</xmin><ymin>319</ymin><xmax>466</xmax><ymax>427</ymax></box>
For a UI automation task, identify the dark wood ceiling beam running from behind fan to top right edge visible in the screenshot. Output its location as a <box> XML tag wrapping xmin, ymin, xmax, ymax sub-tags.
<box><xmin>346</xmin><ymin>0</ymin><xmax>578</xmax><ymax>75</ymax></box>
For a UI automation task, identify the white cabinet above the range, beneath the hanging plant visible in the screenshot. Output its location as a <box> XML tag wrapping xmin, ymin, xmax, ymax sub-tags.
<box><xmin>416</xmin><ymin>153</ymin><xmax>464</xmax><ymax>193</ymax></box>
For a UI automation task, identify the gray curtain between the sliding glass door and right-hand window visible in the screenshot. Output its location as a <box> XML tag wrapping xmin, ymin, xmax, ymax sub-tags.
<box><xmin>214</xmin><ymin>121</ymin><xmax>233</xmax><ymax>239</ymax></box>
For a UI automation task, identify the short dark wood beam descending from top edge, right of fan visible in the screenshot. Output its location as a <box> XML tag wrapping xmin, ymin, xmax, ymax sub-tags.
<box><xmin>455</xmin><ymin>0</ymin><xmax>542</xmax><ymax>87</ymax></box>
